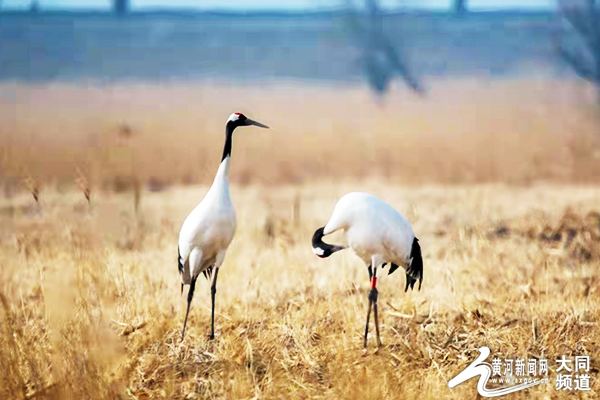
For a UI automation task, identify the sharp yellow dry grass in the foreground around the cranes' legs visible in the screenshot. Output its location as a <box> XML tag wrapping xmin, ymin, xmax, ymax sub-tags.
<box><xmin>0</xmin><ymin>180</ymin><xmax>600</xmax><ymax>399</ymax></box>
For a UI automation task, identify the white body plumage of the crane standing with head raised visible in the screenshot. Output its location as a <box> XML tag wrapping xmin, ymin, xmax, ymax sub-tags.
<box><xmin>179</xmin><ymin>157</ymin><xmax>236</xmax><ymax>285</ymax></box>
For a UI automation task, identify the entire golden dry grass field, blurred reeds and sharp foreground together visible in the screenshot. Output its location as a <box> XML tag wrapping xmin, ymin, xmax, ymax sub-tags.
<box><xmin>0</xmin><ymin>77</ymin><xmax>600</xmax><ymax>399</ymax></box>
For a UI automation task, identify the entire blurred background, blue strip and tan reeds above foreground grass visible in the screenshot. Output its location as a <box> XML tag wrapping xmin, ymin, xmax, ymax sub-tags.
<box><xmin>0</xmin><ymin>0</ymin><xmax>600</xmax><ymax>193</ymax></box>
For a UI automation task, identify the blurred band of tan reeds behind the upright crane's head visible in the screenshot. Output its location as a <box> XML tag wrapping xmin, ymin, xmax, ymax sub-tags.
<box><xmin>0</xmin><ymin>79</ymin><xmax>600</xmax><ymax>191</ymax></box>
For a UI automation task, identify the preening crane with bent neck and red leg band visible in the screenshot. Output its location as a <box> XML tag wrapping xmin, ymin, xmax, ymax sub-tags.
<box><xmin>312</xmin><ymin>192</ymin><xmax>423</xmax><ymax>348</ymax></box>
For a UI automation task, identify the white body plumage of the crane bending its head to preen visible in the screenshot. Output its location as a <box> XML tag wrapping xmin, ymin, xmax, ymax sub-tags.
<box><xmin>317</xmin><ymin>192</ymin><xmax>415</xmax><ymax>269</ymax></box>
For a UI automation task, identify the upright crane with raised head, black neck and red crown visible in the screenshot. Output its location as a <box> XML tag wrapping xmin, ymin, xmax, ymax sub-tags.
<box><xmin>177</xmin><ymin>113</ymin><xmax>268</xmax><ymax>340</ymax></box>
